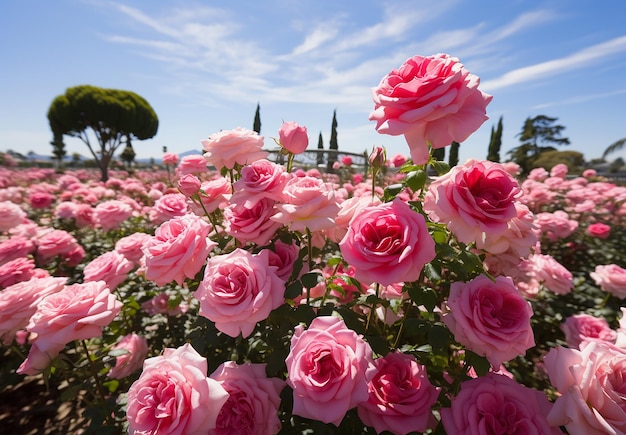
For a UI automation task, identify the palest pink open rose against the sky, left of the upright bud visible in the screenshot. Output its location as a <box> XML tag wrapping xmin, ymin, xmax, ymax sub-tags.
<box><xmin>201</xmin><ymin>127</ymin><xmax>267</xmax><ymax>169</ymax></box>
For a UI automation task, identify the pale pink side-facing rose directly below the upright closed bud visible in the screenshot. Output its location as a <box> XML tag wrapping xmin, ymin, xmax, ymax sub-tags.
<box><xmin>271</xmin><ymin>176</ymin><xmax>339</xmax><ymax>232</ymax></box>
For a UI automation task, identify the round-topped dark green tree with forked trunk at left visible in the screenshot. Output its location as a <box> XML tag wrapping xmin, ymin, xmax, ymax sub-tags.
<box><xmin>48</xmin><ymin>85</ymin><xmax>159</xmax><ymax>181</ymax></box>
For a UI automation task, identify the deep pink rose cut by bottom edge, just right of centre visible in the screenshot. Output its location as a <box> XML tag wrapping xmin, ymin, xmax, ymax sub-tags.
<box><xmin>358</xmin><ymin>352</ymin><xmax>441</xmax><ymax>435</ymax></box>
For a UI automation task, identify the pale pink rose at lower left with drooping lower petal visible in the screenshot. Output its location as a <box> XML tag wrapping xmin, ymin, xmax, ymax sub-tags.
<box><xmin>17</xmin><ymin>281</ymin><xmax>122</xmax><ymax>375</ymax></box>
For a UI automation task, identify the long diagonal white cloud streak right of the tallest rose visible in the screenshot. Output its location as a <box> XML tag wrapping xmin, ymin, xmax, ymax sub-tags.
<box><xmin>482</xmin><ymin>36</ymin><xmax>626</xmax><ymax>92</ymax></box>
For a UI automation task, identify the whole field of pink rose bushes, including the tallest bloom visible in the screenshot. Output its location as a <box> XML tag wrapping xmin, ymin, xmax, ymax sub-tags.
<box><xmin>0</xmin><ymin>54</ymin><xmax>626</xmax><ymax>435</ymax></box>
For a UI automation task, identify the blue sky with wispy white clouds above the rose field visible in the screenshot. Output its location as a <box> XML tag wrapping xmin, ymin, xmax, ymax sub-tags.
<box><xmin>0</xmin><ymin>0</ymin><xmax>626</xmax><ymax>165</ymax></box>
